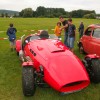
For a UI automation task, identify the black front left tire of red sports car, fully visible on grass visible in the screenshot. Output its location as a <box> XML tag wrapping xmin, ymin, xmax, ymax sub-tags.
<box><xmin>22</xmin><ymin>66</ymin><xmax>36</xmax><ymax>96</ymax></box>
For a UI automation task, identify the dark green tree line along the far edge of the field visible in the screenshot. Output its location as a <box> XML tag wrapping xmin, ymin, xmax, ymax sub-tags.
<box><xmin>1</xmin><ymin>6</ymin><xmax>97</xmax><ymax>18</ymax></box>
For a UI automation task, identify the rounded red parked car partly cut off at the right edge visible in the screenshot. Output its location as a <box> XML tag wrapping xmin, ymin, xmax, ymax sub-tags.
<box><xmin>78</xmin><ymin>24</ymin><xmax>100</xmax><ymax>56</ymax></box>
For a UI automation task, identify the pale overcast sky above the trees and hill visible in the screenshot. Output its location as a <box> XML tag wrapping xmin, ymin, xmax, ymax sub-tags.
<box><xmin>0</xmin><ymin>0</ymin><xmax>100</xmax><ymax>13</ymax></box>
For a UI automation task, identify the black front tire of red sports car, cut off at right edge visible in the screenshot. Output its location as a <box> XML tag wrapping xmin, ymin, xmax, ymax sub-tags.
<box><xmin>91</xmin><ymin>59</ymin><xmax>100</xmax><ymax>83</ymax></box>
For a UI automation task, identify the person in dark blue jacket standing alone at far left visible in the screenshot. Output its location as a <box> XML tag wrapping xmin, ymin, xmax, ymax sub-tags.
<box><xmin>7</xmin><ymin>23</ymin><xmax>17</xmax><ymax>51</ymax></box>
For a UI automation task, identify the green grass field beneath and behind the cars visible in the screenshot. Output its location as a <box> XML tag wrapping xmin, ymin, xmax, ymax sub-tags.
<box><xmin>0</xmin><ymin>18</ymin><xmax>100</xmax><ymax>100</ymax></box>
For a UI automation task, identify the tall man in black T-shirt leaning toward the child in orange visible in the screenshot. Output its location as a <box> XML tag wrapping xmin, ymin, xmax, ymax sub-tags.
<box><xmin>59</xmin><ymin>16</ymin><xmax>68</xmax><ymax>47</ymax></box>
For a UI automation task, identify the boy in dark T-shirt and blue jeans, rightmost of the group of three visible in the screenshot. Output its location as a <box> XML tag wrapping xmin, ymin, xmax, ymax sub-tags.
<box><xmin>68</xmin><ymin>18</ymin><xmax>76</xmax><ymax>52</ymax></box>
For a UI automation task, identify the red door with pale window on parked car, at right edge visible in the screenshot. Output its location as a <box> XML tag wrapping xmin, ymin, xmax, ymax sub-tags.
<box><xmin>90</xmin><ymin>28</ymin><xmax>100</xmax><ymax>56</ymax></box>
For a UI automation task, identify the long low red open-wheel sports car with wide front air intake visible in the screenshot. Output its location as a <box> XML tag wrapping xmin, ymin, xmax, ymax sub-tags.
<box><xmin>16</xmin><ymin>31</ymin><xmax>100</xmax><ymax>96</ymax></box>
